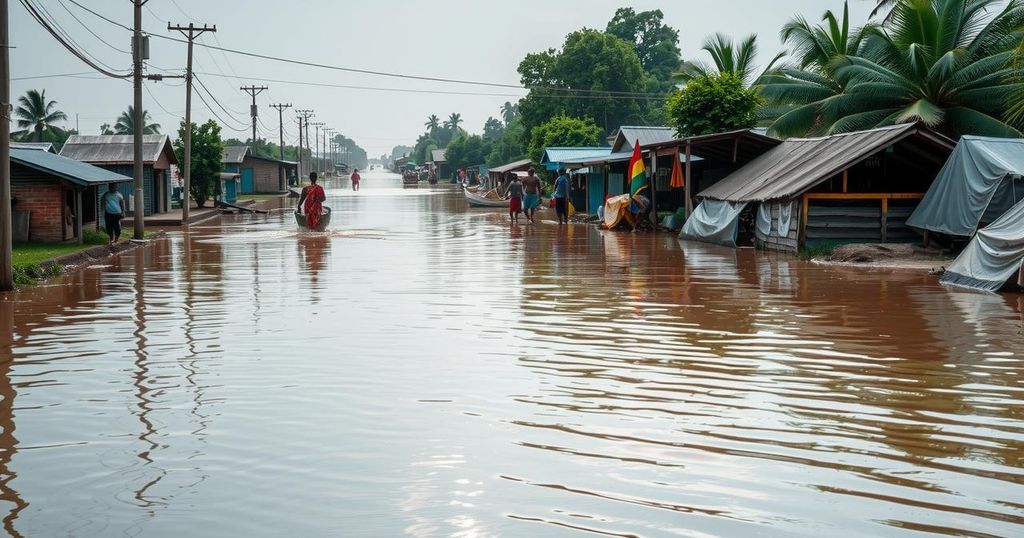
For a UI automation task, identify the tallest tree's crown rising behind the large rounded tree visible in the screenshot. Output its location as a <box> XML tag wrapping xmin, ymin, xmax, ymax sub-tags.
<box><xmin>605</xmin><ymin>7</ymin><xmax>681</xmax><ymax>81</ymax></box>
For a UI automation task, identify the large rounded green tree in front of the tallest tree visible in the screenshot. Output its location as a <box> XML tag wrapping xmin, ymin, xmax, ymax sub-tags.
<box><xmin>518</xmin><ymin>29</ymin><xmax>647</xmax><ymax>132</ymax></box>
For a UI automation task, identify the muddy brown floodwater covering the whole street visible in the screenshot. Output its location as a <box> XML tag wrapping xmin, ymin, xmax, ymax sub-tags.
<box><xmin>0</xmin><ymin>170</ymin><xmax>1024</xmax><ymax>537</ymax></box>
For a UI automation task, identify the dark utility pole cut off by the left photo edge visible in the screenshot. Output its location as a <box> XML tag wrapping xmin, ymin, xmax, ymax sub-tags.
<box><xmin>0</xmin><ymin>0</ymin><xmax>14</xmax><ymax>291</ymax></box>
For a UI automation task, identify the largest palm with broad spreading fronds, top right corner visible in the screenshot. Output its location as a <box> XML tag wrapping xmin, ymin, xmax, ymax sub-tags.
<box><xmin>820</xmin><ymin>0</ymin><xmax>1024</xmax><ymax>136</ymax></box>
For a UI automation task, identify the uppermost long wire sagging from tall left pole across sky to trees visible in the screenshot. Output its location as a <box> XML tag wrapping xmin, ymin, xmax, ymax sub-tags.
<box><xmin>64</xmin><ymin>0</ymin><xmax>668</xmax><ymax>99</ymax></box>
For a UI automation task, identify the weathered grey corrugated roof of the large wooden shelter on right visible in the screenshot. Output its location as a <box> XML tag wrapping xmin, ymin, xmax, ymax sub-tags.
<box><xmin>699</xmin><ymin>123</ymin><xmax>953</xmax><ymax>202</ymax></box>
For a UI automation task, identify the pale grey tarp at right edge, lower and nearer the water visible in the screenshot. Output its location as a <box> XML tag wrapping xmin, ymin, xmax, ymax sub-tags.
<box><xmin>941</xmin><ymin>196</ymin><xmax>1024</xmax><ymax>291</ymax></box>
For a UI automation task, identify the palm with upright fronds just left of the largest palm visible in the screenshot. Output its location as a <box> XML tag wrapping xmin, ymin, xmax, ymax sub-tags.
<box><xmin>761</xmin><ymin>3</ymin><xmax>876</xmax><ymax>136</ymax></box>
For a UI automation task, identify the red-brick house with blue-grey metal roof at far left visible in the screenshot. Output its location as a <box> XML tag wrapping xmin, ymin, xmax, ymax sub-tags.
<box><xmin>10</xmin><ymin>148</ymin><xmax>132</xmax><ymax>243</ymax></box>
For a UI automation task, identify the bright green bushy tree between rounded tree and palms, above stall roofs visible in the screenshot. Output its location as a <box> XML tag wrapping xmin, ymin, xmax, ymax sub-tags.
<box><xmin>668</xmin><ymin>73</ymin><xmax>760</xmax><ymax>136</ymax></box>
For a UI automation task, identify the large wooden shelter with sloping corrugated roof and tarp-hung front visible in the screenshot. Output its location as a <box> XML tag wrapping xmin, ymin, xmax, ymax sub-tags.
<box><xmin>680</xmin><ymin>123</ymin><xmax>953</xmax><ymax>252</ymax></box>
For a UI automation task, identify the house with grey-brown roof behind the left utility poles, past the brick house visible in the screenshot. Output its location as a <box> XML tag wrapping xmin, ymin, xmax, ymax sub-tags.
<box><xmin>60</xmin><ymin>134</ymin><xmax>178</xmax><ymax>215</ymax></box>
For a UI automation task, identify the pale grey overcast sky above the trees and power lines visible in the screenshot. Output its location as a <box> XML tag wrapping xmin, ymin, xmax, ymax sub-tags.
<box><xmin>10</xmin><ymin>0</ymin><xmax>872</xmax><ymax>156</ymax></box>
